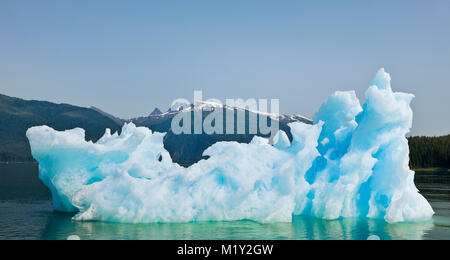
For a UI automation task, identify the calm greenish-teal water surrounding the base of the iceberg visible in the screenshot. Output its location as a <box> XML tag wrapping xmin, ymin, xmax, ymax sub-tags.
<box><xmin>0</xmin><ymin>164</ymin><xmax>450</xmax><ymax>239</ymax></box>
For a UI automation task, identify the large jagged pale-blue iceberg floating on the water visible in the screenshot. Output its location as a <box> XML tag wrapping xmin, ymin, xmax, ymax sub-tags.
<box><xmin>27</xmin><ymin>69</ymin><xmax>434</xmax><ymax>223</ymax></box>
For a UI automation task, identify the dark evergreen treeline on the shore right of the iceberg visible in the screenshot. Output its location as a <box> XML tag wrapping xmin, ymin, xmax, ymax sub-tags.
<box><xmin>408</xmin><ymin>135</ymin><xmax>450</xmax><ymax>168</ymax></box>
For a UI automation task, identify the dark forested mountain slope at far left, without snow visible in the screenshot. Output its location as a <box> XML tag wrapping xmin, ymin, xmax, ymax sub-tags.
<box><xmin>0</xmin><ymin>94</ymin><xmax>121</xmax><ymax>161</ymax></box>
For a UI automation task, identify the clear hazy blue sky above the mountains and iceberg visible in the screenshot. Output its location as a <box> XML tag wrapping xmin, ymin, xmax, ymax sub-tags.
<box><xmin>0</xmin><ymin>0</ymin><xmax>450</xmax><ymax>135</ymax></box>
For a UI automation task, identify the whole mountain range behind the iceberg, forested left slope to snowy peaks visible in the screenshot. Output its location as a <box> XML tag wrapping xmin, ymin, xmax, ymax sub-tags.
<box><xmin>0</xmin><ymin>95</ymin><xmax>312</xmax><ymax>166</ymax></box>
